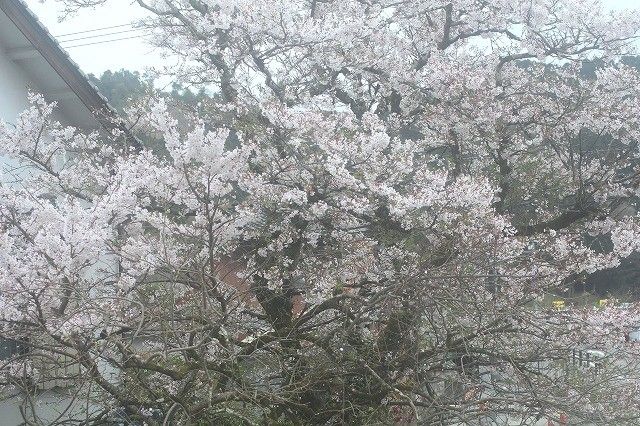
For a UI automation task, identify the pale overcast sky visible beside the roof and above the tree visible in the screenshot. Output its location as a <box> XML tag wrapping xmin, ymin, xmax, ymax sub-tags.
<box><xmin>27</xmin><ymin>0</ymin><xmax>640</xmax><ymax>75</ymax></box>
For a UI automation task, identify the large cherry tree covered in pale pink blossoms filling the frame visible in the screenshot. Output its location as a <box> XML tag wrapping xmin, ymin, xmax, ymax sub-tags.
<box><xmin>0</xmin><ymin>0</ymin><xmax>640</xmax><ymax>425</ymax></box>
